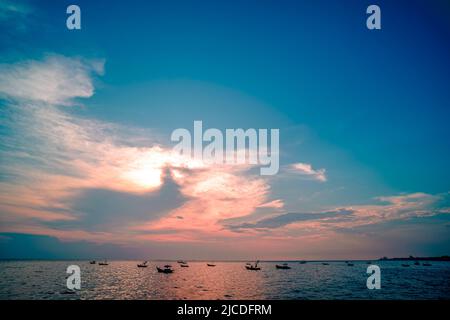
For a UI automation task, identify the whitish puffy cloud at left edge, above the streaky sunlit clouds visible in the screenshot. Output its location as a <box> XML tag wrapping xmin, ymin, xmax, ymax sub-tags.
<box><xmin>0</xmin><ymin>55</ymin><xmax>104</xmax><ymax>105</ymax></box>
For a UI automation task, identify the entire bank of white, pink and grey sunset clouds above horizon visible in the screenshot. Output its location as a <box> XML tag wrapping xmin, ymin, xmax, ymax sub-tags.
<box><xmin>0</xmin><ymin>55</ymin><xmax>450</xmax><ymax>258</ymax></box>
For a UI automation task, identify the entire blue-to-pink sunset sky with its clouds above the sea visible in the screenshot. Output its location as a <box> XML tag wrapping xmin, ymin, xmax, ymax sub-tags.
<box><xmin>0</xmin><ymin>0</ymin><xmax>450</xmax><ymax>260</ymax></box>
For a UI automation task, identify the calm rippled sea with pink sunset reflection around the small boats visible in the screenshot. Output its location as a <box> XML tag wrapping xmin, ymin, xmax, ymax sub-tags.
<box><xmin>0</xmin><ymin>261</ymin><xmax>450</xmax><ymax>299</ymax></box>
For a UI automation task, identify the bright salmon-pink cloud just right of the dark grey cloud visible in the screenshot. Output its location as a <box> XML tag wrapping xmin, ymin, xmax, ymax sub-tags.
<box><xmin>135</xmin><ymin>166</ymin><xmax>269</xmax><ymax>239</ymax></box>
